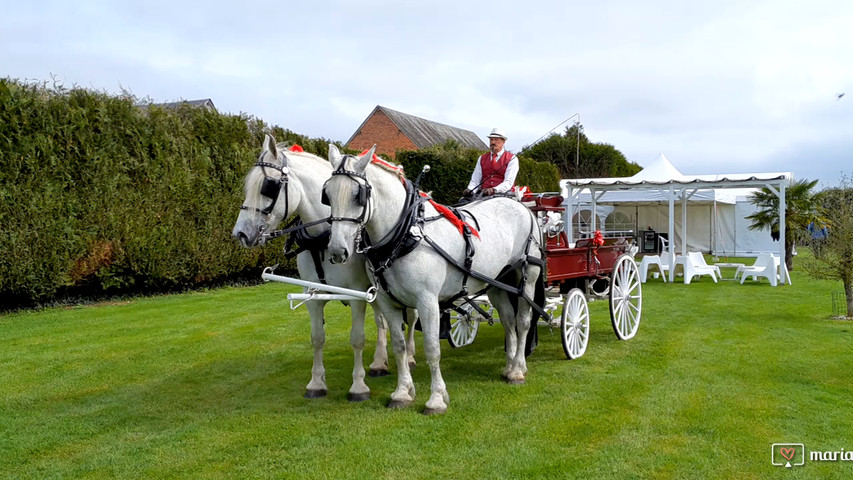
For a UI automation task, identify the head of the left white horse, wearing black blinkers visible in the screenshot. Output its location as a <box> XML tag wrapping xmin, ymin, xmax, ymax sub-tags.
<box><xmin>231</xmin><ymin>134</ymin><xmax>301</xmax><ymax>247</ymax></box>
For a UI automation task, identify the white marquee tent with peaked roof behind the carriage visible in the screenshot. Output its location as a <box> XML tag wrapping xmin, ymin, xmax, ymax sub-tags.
<box><xmin>560</xmin><ymin>154</ymin><xmax>793</xmax><ymax>282</ymax></box>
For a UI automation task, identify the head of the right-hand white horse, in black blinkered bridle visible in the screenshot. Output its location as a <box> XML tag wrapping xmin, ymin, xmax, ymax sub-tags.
<box><xmin>323</xmin><ymin>144</ymin><xmax>376</xmax><ymax>263</ymax></box>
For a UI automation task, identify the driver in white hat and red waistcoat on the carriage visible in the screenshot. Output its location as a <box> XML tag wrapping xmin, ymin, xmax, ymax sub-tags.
<box><xmin>462</xmin><ymin>128</ymin><xmax>518</xmax><ymax>197</ymax></box>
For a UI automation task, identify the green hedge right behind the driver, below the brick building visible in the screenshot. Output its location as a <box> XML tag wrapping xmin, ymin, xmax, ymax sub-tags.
<box><xmin>396</xmin><ymin>140</ymin><xmax>560</xmax><ymax>204</ymax></box>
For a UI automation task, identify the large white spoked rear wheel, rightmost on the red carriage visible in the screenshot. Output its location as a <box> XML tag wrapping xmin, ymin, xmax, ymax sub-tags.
<box><xmin>610</xmin><ymin>255</ymin><xmax>643</xmax><ymax>340</ymax></box>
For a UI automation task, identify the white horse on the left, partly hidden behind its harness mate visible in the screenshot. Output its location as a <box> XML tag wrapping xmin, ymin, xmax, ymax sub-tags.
<box><xmin>226</xmin><ymin>135</ymin><xmax>414</xmax><ymax>401</ymax></box>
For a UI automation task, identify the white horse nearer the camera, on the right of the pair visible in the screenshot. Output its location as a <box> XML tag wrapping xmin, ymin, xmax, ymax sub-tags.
<box><xmin>323</xmin><ymin>145</ymin><xmax>542</xmax><ymax>414</ymax></box>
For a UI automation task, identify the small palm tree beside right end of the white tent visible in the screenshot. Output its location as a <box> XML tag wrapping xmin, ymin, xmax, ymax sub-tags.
<box><xmin>746</xmin><ymin>178</ymin><xmax>826</xmax><ymax>271</ymax></box>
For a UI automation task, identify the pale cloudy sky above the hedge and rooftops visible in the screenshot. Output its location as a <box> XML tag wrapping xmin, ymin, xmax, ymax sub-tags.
<box><xmin>0</xmin><ymin>0</ymin><xmax>853</xmax><ymax>186</ymax></box>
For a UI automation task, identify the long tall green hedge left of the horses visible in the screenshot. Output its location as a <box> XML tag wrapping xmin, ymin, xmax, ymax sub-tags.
<box><xmin>0</xmin><ymin>79</ymin><xmax>328</xmax><ymax>307</ymax></box>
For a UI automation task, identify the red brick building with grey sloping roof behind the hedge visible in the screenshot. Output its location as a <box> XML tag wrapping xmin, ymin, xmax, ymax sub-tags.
<box><xmin>346</xmin><ymin>105</ymin><xmax>482</xmax><ymax>158</ymax></box>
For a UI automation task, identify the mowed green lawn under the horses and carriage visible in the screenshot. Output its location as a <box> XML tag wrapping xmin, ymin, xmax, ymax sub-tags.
<box><xmin>0</xmin><ymin>258</ymin><xmax>853</xmax><ymax>479</ymax></box>
